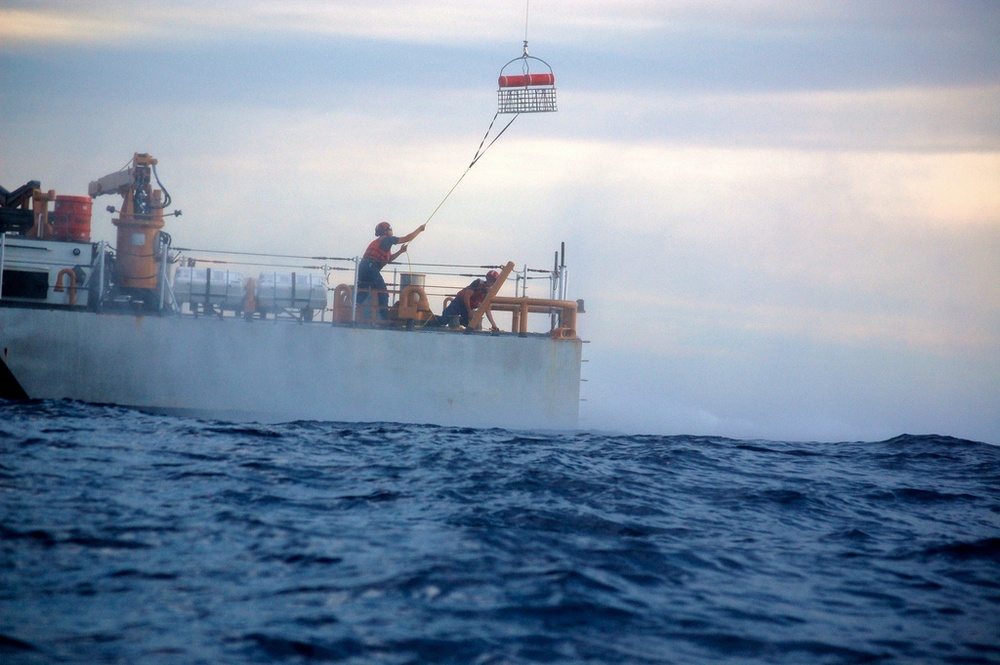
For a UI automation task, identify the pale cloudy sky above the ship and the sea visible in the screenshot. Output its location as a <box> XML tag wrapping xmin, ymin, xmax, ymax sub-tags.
<box><xmin>0</xmin><ymin>0</ymin><xmax>1000</xmax><ymax>444</ymax></box>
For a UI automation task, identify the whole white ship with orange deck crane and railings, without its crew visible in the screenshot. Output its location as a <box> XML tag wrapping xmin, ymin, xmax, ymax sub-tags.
<box><xmin>0</xmin><ymin>153</ymin><xmax>585</xmax><ymax>430</ymax></box>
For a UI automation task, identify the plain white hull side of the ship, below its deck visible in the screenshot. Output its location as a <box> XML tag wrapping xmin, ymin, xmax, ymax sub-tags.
<box><xmin>0</xmin><ymin>307</ymin><xmax>582</xmax><ymax>429</ymax></box>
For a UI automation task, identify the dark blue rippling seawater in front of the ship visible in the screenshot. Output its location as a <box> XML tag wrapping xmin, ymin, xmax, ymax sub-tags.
<box><xmin>0</xmin><ymin>401</ymin><xmax>1000</xmax><ymax>664</ymax></box>
